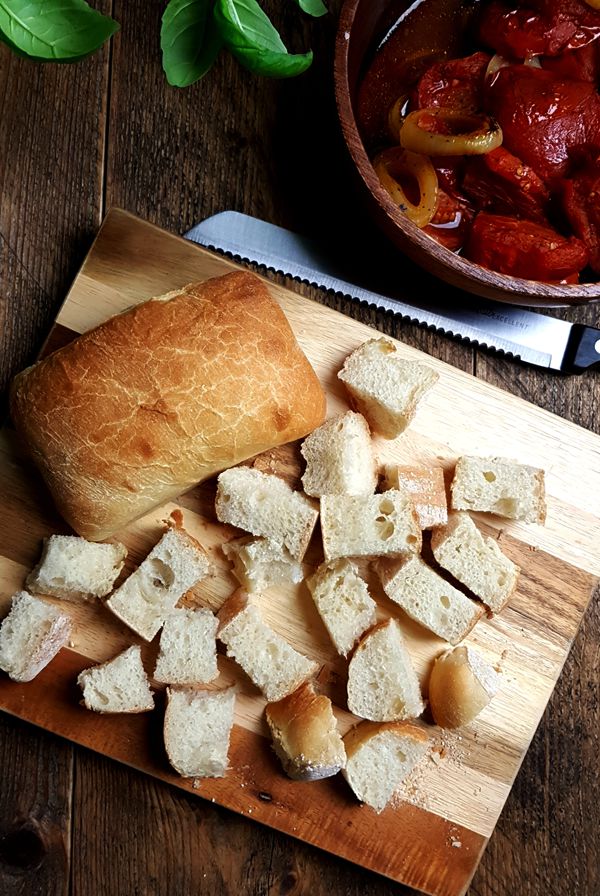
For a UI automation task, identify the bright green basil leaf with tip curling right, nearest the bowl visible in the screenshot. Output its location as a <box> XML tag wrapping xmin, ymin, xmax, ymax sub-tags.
<box><xmin>214</xmin><ymin>0</ymin><xmax>312</xmax><ymax>78</ymax></box>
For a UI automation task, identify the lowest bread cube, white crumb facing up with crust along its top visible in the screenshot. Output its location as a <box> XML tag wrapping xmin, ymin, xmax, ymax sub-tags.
<box><xmin>342</xmin><ymin>722</ymin><xmax>429</xmax><ymax>813</ymax></box>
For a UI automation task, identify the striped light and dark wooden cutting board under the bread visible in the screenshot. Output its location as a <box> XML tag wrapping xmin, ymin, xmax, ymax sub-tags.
<box><xmin>0</xmin><ymin>210</ymin><xmax>600</xmax><ymax>896</ymax></box>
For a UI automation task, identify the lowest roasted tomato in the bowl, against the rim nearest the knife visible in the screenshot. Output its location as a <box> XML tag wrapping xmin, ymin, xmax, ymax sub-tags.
<box><xmin>465</xmin><ymin>212</ymin><xmax>588</xmax><ymax>281</ymax></box>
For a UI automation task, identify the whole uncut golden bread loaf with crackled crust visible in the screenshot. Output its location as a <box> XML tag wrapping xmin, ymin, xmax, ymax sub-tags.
<box><xmin>11</xmin><ymin>271</ymin><xmax>325</xmax><ymax>541</ymax></box>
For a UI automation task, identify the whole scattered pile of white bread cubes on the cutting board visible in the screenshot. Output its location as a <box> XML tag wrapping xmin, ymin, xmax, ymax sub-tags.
<box><xmin>0</xmin><ymin>338</ymin><xmax>545</xmax><ymax>812</ymax></box>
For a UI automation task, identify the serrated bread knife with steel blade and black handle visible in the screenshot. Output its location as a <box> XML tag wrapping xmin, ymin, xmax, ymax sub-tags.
<box><xmin>185</xmin><ymin>211</ymin><xmax>600</xmax><ymax>373</ymax></box>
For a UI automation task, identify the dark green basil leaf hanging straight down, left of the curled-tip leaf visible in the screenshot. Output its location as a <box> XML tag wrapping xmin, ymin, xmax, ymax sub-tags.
<box><xmin>160</xmin><ymin>0</ymin><xmax>222</xmax><ymax>87</ymax></box>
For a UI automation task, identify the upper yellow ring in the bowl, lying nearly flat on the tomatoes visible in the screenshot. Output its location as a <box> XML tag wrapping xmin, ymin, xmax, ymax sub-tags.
<box><xmin>400</xmin><ymin>107</ymin><xmax>502</xmax><ymax>156</ymax></box>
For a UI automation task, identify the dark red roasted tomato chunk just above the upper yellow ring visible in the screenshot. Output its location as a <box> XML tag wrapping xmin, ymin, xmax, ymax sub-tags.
<box><xmin>415</xmin><ymin>53</ymin><xmax>490</xmax><ymax>112</ymax></box>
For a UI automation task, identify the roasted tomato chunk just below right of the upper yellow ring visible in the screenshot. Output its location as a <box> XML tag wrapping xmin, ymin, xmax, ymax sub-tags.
<box><xmin>462</xmin><ymin>146</ymin><xmax>550</xmax><ymax>224</ymax></box>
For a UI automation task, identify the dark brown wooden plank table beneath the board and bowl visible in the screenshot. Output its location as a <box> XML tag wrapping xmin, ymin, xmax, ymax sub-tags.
<box><xmin>0</xmin><ymin>0</ymin><xmax>600</xmax><ymax>896</ymax></box>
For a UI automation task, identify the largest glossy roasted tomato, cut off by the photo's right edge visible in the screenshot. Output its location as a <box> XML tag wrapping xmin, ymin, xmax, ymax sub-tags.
<box><xmin>487</xmin><ymin>65</ymin><xmax>600</xmax><ymax>185</ymax></box>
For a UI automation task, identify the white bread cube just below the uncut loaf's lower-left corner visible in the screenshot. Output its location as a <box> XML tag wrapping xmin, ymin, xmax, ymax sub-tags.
<box><xmin>25</xmin><ymin>535</ymin><xmax>127</xmax><ymax>601</ymax></box>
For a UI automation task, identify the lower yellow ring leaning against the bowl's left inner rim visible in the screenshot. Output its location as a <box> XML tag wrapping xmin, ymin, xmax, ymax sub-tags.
<box><xmin>373</xmin><ymin>146</ymin><xmax>438</xmax><ymax>227</ymax></box>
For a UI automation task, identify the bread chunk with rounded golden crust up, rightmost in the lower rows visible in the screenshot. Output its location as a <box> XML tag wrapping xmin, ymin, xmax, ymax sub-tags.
<box><xmin>429</xmin><ymin>646</ymin><xmax>500</xmax><ymax>728</ymax></box>
